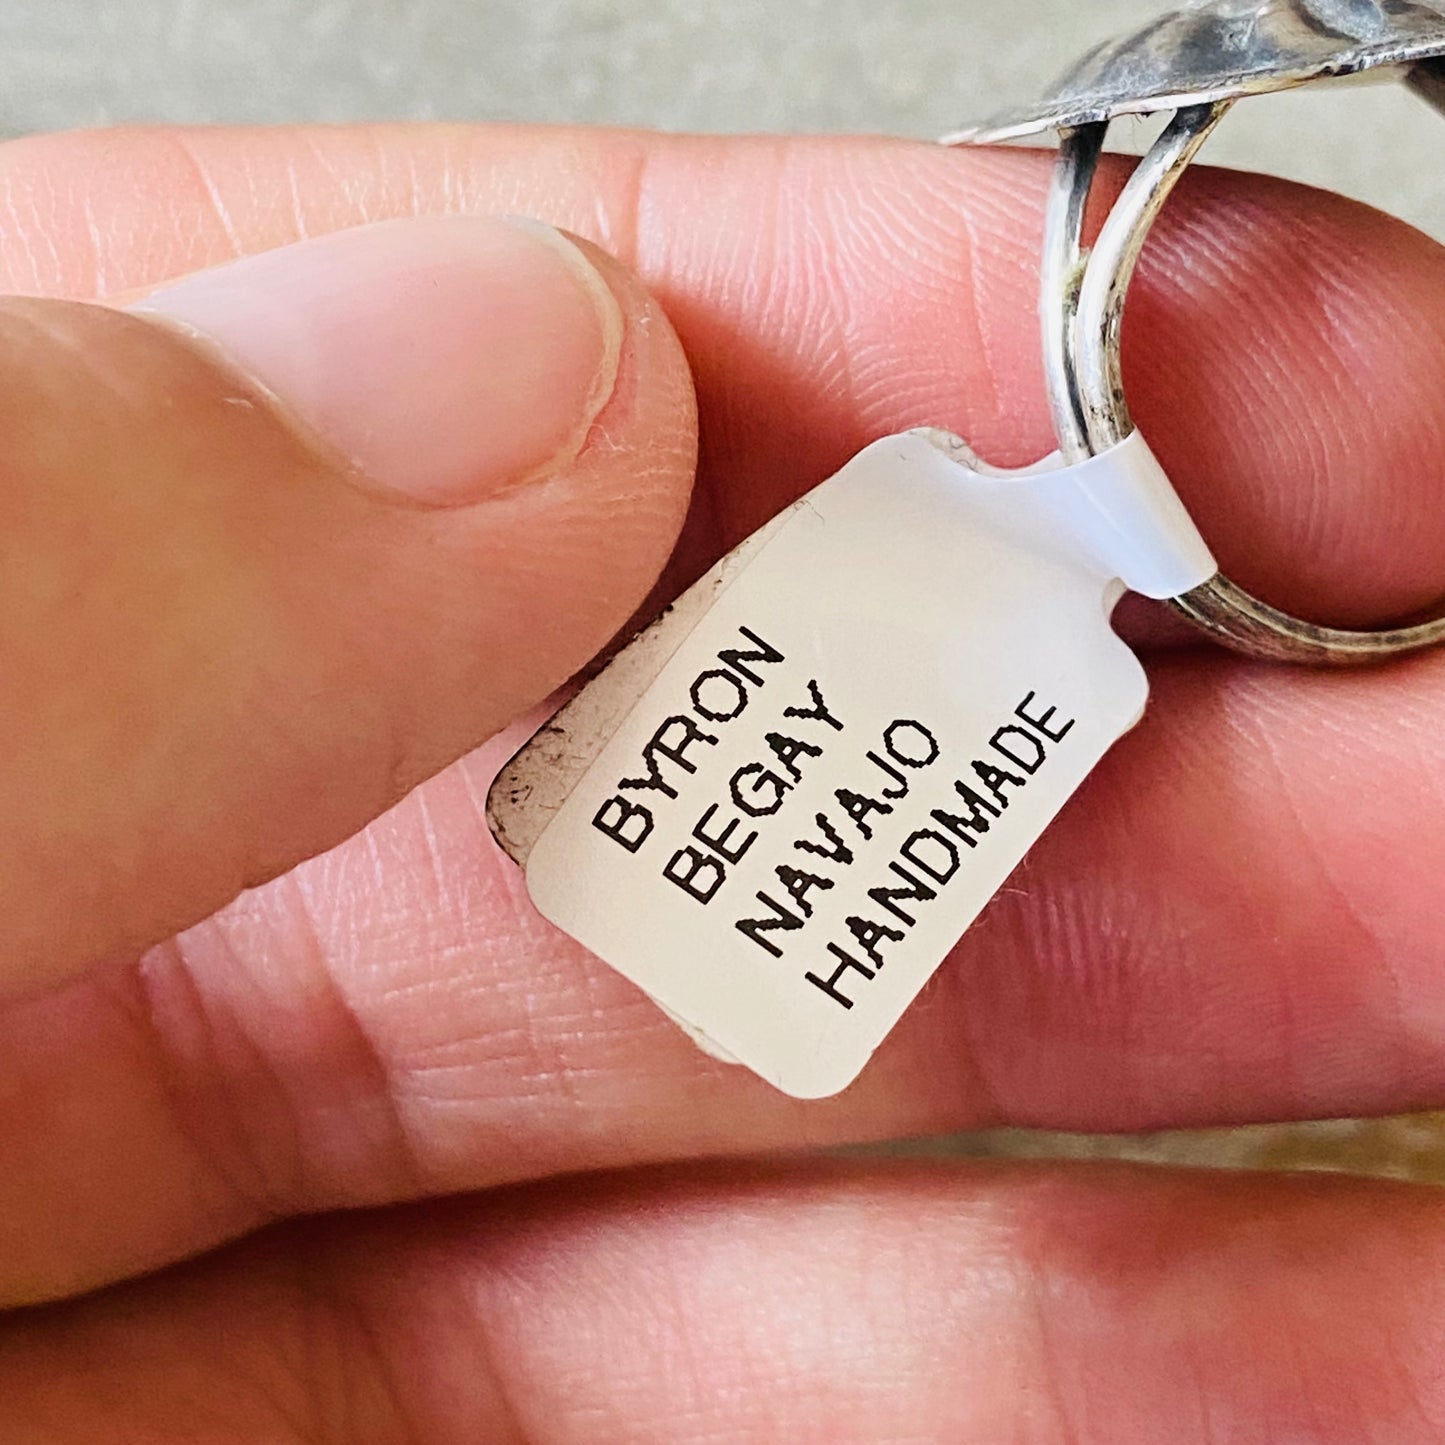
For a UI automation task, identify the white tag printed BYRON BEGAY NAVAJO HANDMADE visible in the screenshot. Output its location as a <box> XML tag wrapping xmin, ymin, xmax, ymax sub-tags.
<box><xmin>491</xmin><ymin>432</ymin><xmax>1214</xmax><ymax>1098</ymax></box>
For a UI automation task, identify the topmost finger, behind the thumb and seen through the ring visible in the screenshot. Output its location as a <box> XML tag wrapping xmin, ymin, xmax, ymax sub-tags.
<box><xmin>0</xmin><ymin>126</ymin><xmax>1445</xmax><ymax>623</ymax></box>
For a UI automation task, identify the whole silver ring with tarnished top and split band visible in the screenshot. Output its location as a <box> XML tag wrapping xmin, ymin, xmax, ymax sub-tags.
<box><xmin>945</xmin><ymin>0</ymin><xmax>1445</xmax><ymax>668</ymax></box>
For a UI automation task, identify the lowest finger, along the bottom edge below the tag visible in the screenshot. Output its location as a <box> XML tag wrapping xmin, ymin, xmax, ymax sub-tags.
<box><xmin>0</xmin><ymin>1165</ymin><xmax>1445</xmax><ymax>1445</ymax></box>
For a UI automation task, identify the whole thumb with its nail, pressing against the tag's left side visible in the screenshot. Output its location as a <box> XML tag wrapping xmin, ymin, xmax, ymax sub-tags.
<box><xmin>0</xmin><ymin>218</ymin><xmax>695</xmax><ymax>991</ymax></box>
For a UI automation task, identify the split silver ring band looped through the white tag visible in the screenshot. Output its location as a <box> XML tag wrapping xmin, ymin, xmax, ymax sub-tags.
<box><xmin>949</xmin><ymin>0</ymin><xmax>1445</xmax><ymax>668</ymax></box>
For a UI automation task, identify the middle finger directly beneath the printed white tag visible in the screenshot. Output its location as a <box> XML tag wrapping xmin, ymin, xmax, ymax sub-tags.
<box><xmin>8</xmin><ymin>650</ymin><xmax>1445</xmax><ymax>1302</ymax></box>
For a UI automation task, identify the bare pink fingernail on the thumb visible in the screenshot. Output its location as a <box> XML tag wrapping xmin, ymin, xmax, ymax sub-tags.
<box><xmin>134</xmin><ymin>217</ymin><xmax>623</xmax><ymax>506</ymax></box>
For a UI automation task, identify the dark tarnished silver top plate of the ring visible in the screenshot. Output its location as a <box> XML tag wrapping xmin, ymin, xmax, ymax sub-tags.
<box><xmin>948</xmin><ymin>0</ymin><xmax>1445</xmax><ymax>145</ymax></box>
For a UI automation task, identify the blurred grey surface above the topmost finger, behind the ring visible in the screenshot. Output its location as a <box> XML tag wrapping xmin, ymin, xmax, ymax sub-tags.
<box><xmin>0</xmin><ymin>0</ymin><xmax>1445</xmax><ymax>236</ymax></box>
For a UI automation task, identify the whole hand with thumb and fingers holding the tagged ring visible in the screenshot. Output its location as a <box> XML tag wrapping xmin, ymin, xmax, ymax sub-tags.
<box><xmin>0</xmin><ymin>129</ymin><xmax>1445</xmax><ymax>1445</ymax></box>
